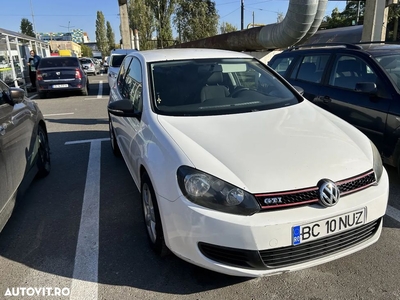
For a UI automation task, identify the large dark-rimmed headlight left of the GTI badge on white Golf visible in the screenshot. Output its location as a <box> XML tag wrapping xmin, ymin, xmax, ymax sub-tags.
<box><xmin>177</xmin><ymin>166</ymin><xmax>260</xmax><ymax>215</ymax></box>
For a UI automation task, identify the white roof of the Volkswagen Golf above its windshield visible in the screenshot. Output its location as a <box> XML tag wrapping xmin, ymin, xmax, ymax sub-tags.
<box><xmin>129</xmin><ymin>48</ymin><xmax>253</xmax><ymax>62</ymax></box>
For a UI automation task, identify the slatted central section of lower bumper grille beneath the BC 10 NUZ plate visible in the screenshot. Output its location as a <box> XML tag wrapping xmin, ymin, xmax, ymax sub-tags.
<box><xmin>260</xmin><ymin>218</ymin><xmax>381</xmax><ymax>268</ymax></box>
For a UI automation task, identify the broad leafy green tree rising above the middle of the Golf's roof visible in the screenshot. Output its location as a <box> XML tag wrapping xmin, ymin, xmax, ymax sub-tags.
<box><xmin>174</xmin><ymin>0</ymin><xmax>219</xmax><ymax>42</ymax></box>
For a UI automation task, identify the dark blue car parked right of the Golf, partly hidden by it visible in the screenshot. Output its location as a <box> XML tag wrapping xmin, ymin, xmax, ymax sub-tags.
<box><xmin>268</xmin><ymin>43</ymin><xmax>400</xmax><ymax>170</ymax></box>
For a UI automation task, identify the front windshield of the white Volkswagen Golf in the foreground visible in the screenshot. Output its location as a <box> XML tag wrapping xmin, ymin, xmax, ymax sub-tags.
<box><xmin>150</xmin><ymin>58</ymin><xmax>299</xmax><ymax>116</ymax></box>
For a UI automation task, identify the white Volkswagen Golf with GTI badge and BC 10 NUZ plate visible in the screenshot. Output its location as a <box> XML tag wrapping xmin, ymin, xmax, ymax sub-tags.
<box><xmin>108</xmin><ymin>49</ymin><xmax>389</xmax><ymax>277</ymax></box>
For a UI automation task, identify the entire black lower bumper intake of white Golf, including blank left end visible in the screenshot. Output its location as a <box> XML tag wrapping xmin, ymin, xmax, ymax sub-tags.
<box><xmin>198</xmin><ymin>218</ymin><xmax>382</xmax><ymax>270</ymax></box>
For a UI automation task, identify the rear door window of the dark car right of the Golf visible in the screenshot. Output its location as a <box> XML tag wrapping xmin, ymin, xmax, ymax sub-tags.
<box><xmin>290</xmin><ymin>54</ymin><xmax>329</xmax><ymax>83</ymax></box>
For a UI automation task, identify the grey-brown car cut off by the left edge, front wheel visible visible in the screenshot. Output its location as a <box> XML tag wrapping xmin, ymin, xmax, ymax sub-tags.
<box><xmin>0</xmin><ymin>80</ymin><xmax>50</xmax><ymax>231</ymax></box>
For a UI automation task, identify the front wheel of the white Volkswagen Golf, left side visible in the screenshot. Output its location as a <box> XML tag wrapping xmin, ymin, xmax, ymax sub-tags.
<box><xmin>140</xmin><ymin>173</ymin><xmax>170</xmax><ymax>257</ymax></box>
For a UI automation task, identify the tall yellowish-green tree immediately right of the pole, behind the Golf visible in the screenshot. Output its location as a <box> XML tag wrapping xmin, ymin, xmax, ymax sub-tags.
<box><xmin>128</xmin><ymin>0</ymin><xmax>156</xmax><ymax>50</ymax></box>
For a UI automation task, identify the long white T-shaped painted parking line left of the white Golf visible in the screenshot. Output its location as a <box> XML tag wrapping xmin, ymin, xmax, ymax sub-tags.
<box><xmin>65</xmin><ymin>139</ymin><xmax>107</xmax><ymax>300</ymax></box>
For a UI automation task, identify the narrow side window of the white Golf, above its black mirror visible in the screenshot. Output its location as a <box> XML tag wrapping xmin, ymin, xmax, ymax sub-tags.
<box><xmin>123</xmin><ymin>58</ymin><xmax>143</xmax><ymax>112</ymax></box>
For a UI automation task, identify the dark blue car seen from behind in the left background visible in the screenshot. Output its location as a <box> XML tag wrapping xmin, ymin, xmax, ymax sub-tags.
<box><xmin>36</xmin><ymin>56</ymin><xmax>89</xmax><ymax>98</ymax></box>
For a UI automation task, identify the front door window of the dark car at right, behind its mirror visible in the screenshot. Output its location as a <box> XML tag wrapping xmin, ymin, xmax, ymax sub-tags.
<box><xmin>329</xmin><ymin>55</ymin><xmax>379</xmax><ymax>90</ymax></box>
